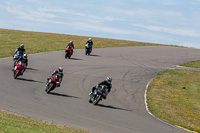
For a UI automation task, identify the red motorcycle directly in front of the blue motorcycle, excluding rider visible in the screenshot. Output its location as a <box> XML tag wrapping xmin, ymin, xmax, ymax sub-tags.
<box><xmin>13</xmin><ymin>61</ymin><xmax>25</xmax><ymax>79</ymax></box>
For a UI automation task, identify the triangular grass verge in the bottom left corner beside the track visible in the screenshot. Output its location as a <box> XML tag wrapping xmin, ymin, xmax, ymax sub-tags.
<box><xmin>0</xmin><ymin>111</ymin><xmax>87</xmax><ymax>133</ymax></box>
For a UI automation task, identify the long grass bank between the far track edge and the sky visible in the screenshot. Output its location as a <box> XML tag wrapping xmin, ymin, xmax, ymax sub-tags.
<box><xmin>0</xmin><ymin>29</ymin><xmax>169</xmax><ymax>57</ymax></box>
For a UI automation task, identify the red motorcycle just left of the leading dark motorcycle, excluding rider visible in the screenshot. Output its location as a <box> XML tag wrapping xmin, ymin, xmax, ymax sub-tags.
<box><xmin>45</xmin><ymin>76</ymin><xmax>60</xmax><ymax>93</ymax></box>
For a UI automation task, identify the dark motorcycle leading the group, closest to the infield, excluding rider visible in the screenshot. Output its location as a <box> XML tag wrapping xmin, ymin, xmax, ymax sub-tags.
<box><xmin>89</xmin><ymin>85</ymin><xmax>108</xmax><ymax>105</ymax></box>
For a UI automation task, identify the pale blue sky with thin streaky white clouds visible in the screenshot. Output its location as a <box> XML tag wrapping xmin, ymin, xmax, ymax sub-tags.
<box><xmin>0</xmin><ymin>0</ymin><xmax>200</xmax><ymax>48</ymax></box>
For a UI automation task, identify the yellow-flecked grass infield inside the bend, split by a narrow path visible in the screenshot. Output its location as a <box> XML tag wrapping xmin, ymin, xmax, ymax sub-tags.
<box><xmin>147</xmin><ymin>61</ymin><xmax>200</xmax><ymax>133</ymax></box>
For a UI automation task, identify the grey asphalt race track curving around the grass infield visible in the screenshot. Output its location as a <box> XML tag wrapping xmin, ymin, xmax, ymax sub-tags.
<box><xmin>0</xmin><ymin>46</ymin><xmax>200</xmax><ymax>133</ymax></box>
